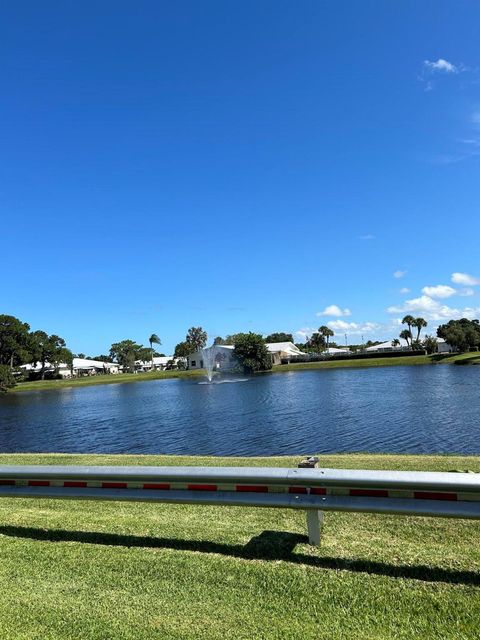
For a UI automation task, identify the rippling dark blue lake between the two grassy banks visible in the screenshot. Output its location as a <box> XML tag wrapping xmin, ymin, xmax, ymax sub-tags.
<box><xmin>0</xmin><ymin>365</ymin><xmax>480</xmax><ymax>456</ymax></box>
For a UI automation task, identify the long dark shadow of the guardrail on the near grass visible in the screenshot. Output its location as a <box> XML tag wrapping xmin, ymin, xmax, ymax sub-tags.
<box><xmin>0</xmin><ymin>525</ymin><xmax>480</xmax><ymax>586</ymax></box>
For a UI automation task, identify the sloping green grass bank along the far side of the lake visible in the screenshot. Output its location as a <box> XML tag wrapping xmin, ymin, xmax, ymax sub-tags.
<box><xmin>10</xmin><ymin>351</ymin><xmax>480</xmax><ymax>393</ymax></box>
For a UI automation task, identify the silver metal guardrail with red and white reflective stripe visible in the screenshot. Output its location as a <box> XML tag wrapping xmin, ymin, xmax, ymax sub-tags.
<box><xmin>0</xmin><ymin>465</ymin><xmax>480</xmax><ymax>545</ymax></box>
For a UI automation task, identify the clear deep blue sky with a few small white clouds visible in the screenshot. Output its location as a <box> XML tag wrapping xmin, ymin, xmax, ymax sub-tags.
<box><xmin>0</xmin><ymin>0</ymin><xmax>480</xmax><ymax>355</ymax></box>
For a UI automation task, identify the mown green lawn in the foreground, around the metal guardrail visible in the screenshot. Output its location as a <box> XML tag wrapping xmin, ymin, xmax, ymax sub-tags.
<box><xmin>0</xmin><ymin>454</ymin><xmax>480</xmax><ymax>640</ymax></box>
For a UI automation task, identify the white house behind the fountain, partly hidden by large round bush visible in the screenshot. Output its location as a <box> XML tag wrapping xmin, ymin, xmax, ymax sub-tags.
<box><xmin>187</xmin><ymin>342</ymin><xmax>304</xmax><ymax>371</ymax></box>
